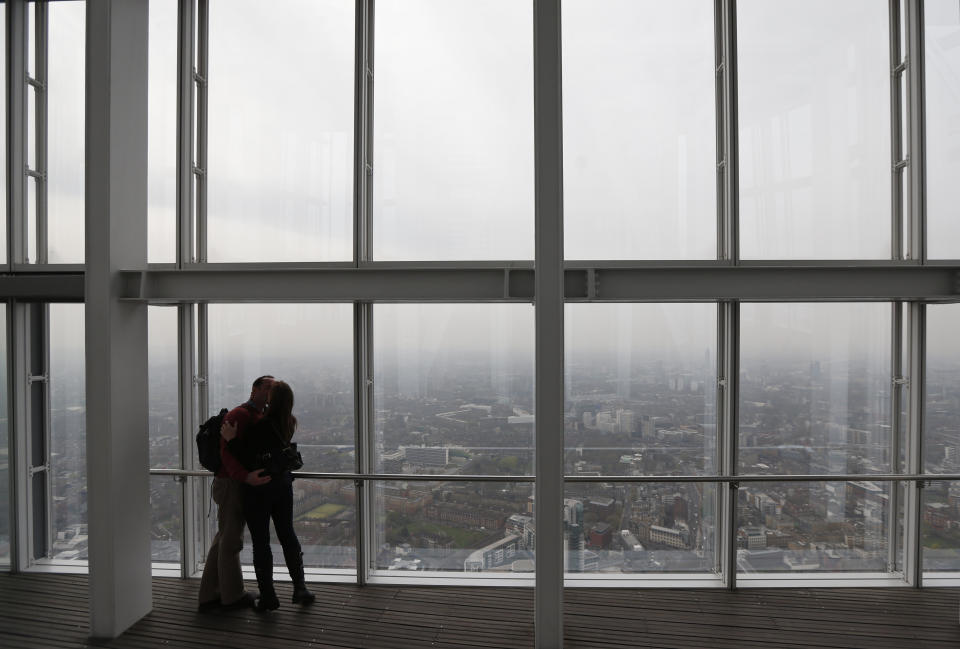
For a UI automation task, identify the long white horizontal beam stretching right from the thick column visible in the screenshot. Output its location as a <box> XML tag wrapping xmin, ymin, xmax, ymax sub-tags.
<box><xmin>107</xmin><ymin>264</ymin><xmax>960</xmax><ymax>303</ymax></box>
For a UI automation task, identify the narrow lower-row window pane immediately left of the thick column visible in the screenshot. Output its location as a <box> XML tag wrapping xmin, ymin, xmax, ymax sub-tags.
<box><xmin>49</xmin><ymin>304</ymin><xmax>87</xmax><ymax>561</ymax></box>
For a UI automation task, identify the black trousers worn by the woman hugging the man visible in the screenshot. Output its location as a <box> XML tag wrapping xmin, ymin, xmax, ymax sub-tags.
<box><xmin>243</xmin><ymin>472</ymin><xmax>303</xmax><ymax>583</ymax></box>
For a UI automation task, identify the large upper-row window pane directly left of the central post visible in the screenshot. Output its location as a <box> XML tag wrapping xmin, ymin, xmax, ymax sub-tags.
<box><xmin>372</xmin><ymin>0</ymin><xmax>534</xmax><ymax>260</ymax></box>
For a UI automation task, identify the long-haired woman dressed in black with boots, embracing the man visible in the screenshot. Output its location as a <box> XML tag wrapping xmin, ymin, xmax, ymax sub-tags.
<box><xmin>221</xmin><ymin>381</ymin><xmax>314</xmax><ymax>611</ymax></box>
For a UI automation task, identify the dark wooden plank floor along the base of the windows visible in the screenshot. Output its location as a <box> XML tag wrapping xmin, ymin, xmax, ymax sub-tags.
<box><xmin>0</xmin><ymin>574</ymin><xmax>960</xmax><ymax>649</ymax></box>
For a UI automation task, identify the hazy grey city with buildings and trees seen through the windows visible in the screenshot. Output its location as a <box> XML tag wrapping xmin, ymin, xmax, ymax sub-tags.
<box><xmin>9</xmin><ymin>308</ymin><xmax>960</xmax><ymax>575</ymax></box>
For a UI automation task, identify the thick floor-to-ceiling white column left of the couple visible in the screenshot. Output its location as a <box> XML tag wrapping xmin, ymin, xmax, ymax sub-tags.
<box><xmin>85</xmin><ymin>0</ymin><xmax>152</xmax><ymax>638</ymax></box>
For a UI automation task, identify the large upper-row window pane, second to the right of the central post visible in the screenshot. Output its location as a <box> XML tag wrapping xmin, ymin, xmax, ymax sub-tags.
<box><xmin>737</xmin><ymin>0</ymin><xmax>891</xmax><ymax>259</ymax></box>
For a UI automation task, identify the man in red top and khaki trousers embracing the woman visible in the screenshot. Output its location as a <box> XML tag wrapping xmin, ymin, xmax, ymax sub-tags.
<box><xmin>199</xmin><ymin>375</ymin><xmax>273</xmax><ymax>611</ymax></box>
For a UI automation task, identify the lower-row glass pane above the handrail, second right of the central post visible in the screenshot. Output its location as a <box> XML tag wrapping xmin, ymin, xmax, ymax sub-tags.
<box><xmin>738</xmin><ymin>303</ymin><xmax>892</xmax><ymax>474</ymax></box>
